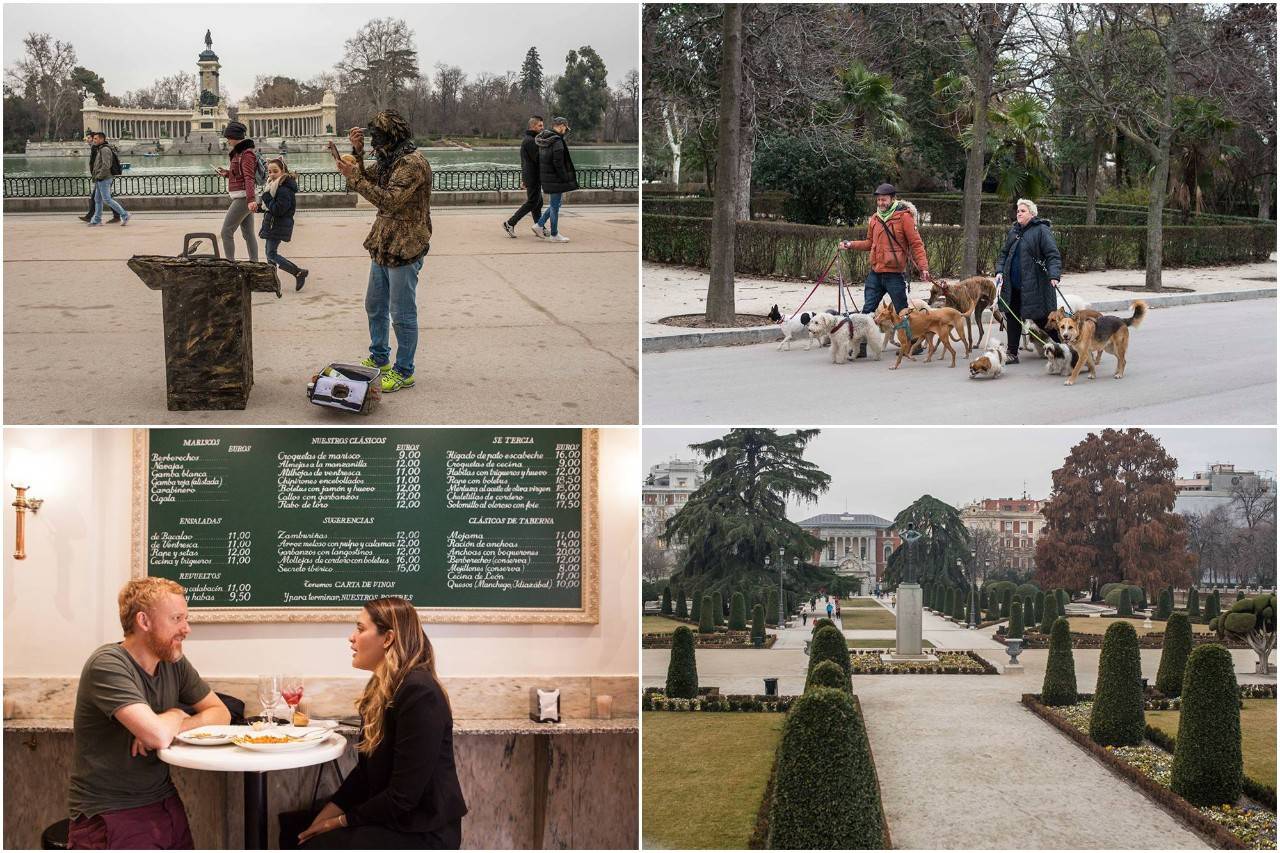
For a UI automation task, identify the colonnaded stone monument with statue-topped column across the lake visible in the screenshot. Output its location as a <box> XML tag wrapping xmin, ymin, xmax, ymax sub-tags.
<box><xmin>81</xmin><ymin>31</ymin><xmax>338</xmax><ymax>143</ymax></box>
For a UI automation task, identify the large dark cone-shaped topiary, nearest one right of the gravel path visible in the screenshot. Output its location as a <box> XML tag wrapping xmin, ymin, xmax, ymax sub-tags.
<box><xmin>1169</xmin><ymin>643</ymin><xmax>1244</xmax><ymax>806</ymax></box>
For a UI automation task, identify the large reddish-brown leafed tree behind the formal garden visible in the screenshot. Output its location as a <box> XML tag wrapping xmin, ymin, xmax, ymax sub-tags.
<box><xmin>1036</xmin><ymin>429</ymin><xmax>1196</xmax><ymax>598</ymax></box>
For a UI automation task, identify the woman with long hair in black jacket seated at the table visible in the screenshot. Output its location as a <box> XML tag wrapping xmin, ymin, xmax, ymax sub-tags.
<box><xmin>298</xmin><ymin>597</ymin><xmax>467</xmax><ymax>850</ymax></box>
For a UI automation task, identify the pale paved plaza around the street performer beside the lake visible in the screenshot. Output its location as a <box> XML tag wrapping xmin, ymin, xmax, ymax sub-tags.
<box><xmin>4</xmin><ymin>204</ymin><xmax>639</xmax><ymax>427</ymax></box>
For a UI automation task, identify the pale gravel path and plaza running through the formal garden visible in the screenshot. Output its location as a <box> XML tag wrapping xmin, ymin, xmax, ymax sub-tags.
<box><xmin>641</xmin><ymin>596</ymin><xmax>1275</xmax><ymax>849</ymax></box>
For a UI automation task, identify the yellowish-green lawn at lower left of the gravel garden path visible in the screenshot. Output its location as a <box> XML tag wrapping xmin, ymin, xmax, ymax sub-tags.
<box><xmin>643</xmin><ymin>711</ymin><xmax>786</xmax><ymax>849</ymax></box>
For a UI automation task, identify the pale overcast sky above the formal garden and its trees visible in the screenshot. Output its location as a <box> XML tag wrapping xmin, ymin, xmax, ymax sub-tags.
<box><xmin>644</xmin><ymin>427</ymin><xmax>1276</xmax><ymax>521</ymax></box>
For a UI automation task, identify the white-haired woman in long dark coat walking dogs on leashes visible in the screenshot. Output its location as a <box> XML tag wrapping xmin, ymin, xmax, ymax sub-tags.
<box><xmin>996</xmin><ymin>199</ymin><xmax>1062</xmax><ymax>364</ymax></box>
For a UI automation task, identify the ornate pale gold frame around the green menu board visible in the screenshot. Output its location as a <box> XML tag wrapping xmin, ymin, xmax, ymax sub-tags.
<box><xmin>131</xmin><ymin>428</ymin><xmax>600</xmax><ymax>625</ymax></box>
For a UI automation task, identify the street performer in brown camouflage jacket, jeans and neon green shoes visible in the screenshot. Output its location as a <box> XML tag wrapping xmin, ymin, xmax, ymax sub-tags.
<box><xmin>330</xmin><ymin>110</ymin><xmax>431</xmax><ymax>393</ymax></box>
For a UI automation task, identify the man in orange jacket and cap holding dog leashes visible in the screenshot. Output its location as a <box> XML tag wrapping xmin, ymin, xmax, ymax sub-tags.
<box><xmin>840</xmin><ymin>183</ymin><xmax>931</xmax><ymax>359</ymax></box>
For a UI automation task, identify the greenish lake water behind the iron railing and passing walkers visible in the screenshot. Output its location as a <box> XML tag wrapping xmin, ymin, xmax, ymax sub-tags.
<box><xmin>4</xmin><ymin>146</ymin><xmax>640</xmax><ymax>178</ymax></box>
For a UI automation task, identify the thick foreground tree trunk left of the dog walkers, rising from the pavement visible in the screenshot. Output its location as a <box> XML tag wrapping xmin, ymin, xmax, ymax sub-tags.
<box><xmin>707</xmin><ymin>3</ymin><xmax>742</xmax><ymax>325</ymax></box>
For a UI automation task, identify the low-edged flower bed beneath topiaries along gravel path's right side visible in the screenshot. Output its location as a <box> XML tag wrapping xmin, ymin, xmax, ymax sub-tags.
<box><xmin>1023</xmin><ymin>693</ymin><xmax>1276</xmax><ymax>850</ymax></box>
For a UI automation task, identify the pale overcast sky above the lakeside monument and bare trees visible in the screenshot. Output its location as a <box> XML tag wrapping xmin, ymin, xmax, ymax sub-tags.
<box><xmin>4</xmin><ymin>3</ymin><xmax>640</xmax><ymax>102</ymax></box>
